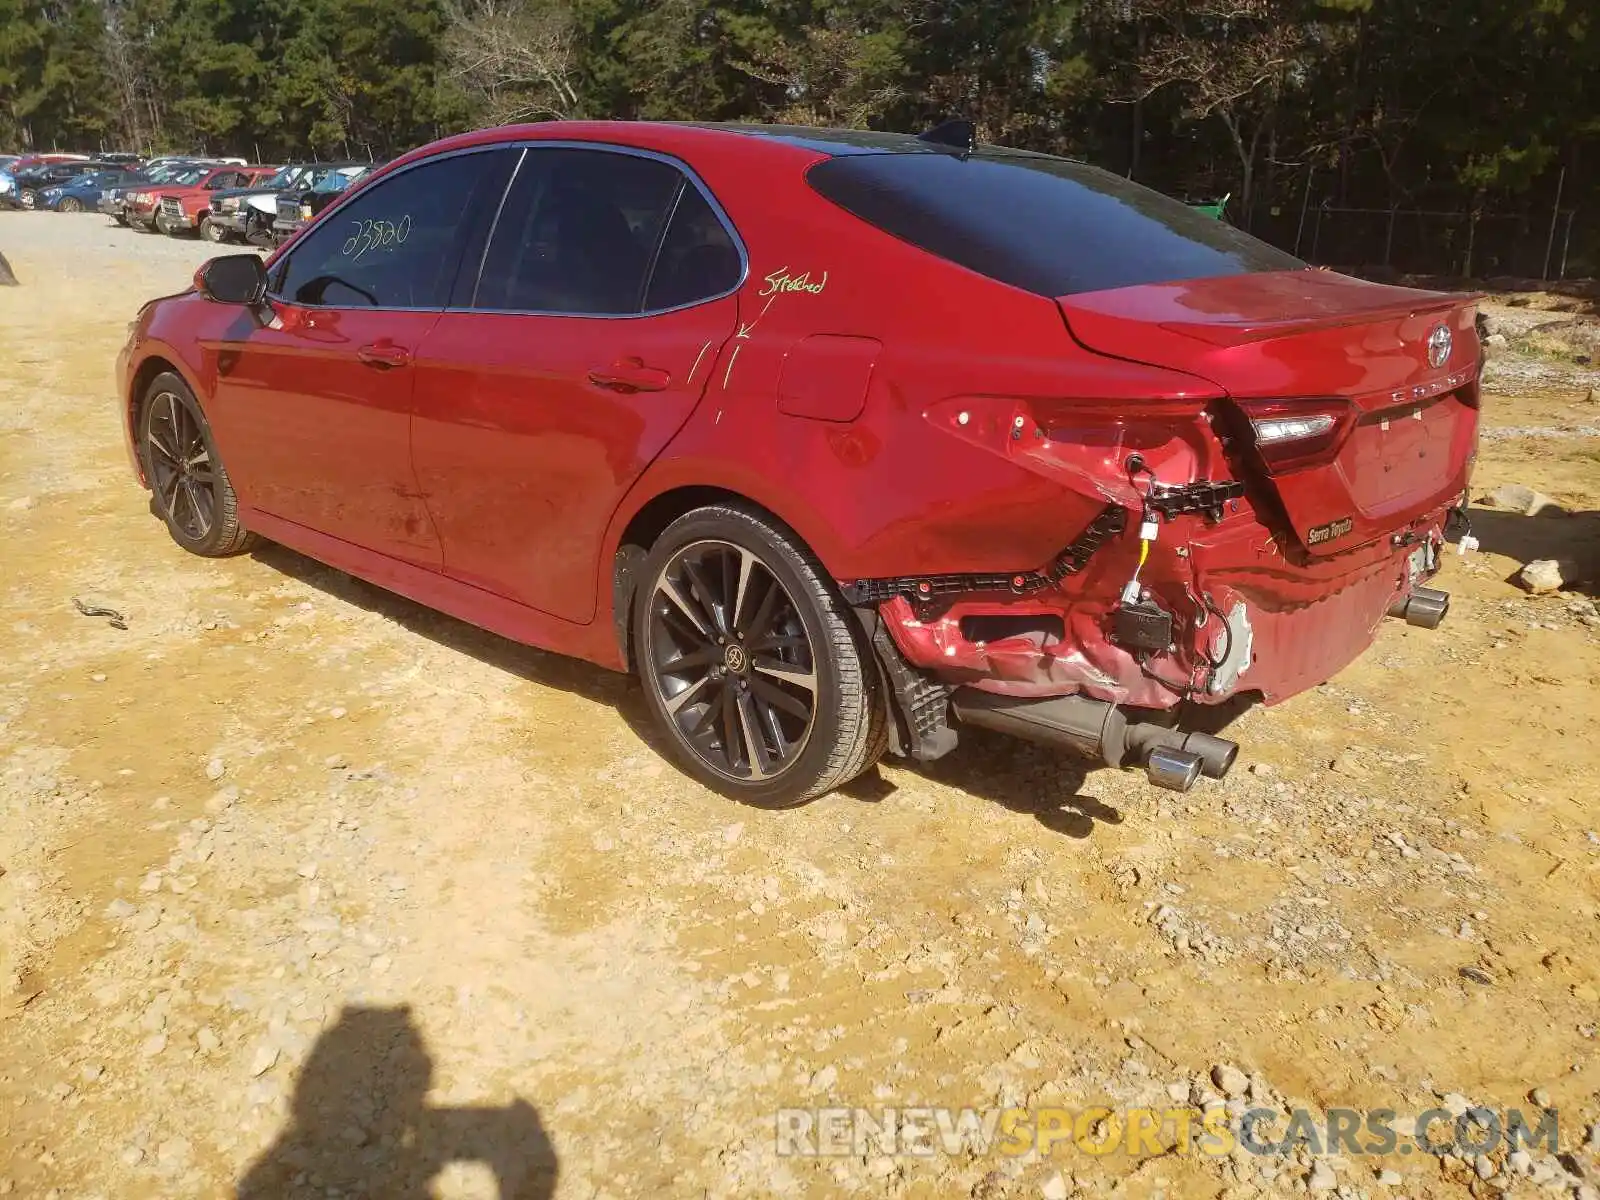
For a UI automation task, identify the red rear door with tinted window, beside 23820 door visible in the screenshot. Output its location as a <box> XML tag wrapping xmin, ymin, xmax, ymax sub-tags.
<box><xmin>413</xmin><ymin>144</ymin><xmax>744</xmax><ymax>622</ymax></box>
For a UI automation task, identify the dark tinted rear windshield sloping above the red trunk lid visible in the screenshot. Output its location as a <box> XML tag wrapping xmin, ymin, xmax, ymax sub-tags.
<box><xmin>806</xmin><ymin>150</ymin><xmax>1306</xmax><ymax>296</ymax></box>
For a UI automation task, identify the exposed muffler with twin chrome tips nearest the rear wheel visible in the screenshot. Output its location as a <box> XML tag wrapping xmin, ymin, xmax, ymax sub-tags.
<box><xmin>950</xmin><ymin>688</ymin><xmax>1238</xmax><ymax>792</ymax></box>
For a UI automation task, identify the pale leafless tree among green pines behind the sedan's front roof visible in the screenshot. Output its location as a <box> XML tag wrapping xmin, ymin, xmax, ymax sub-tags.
<box><xmin>445</xmin><ymin>0</ymin><xmax>578</xmax><ymax>123</ymax></box>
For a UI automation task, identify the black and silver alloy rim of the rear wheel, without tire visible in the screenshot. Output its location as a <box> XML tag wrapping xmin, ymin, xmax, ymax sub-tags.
<box><xmin>645</xmin><ymin>541</ymin><xmax>818</xmax><ymax>782</ymax></box>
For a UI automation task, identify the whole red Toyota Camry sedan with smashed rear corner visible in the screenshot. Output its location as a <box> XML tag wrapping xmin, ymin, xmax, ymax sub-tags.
<box><xmin>120</xmin><ymin>122</ymin><xmax>1482</xmax><ymax>805</ymax></box>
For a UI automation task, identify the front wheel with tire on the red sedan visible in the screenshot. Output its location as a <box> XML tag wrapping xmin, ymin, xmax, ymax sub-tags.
<box><xmin>138</xmin><ymin>371</ymin><xmax>256</xmax><ymax>558</ymax></box>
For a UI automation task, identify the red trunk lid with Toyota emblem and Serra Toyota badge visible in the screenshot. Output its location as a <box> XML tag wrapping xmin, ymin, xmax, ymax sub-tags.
<box><xmin>1058</xmin><ymin>270</ymin><xmax>1480</xmax><ymax>555</ymax></box>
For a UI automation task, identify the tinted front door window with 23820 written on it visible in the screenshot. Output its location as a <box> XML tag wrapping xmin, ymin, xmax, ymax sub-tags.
<box><xmin>274</xmin><ymin>150</ymin><xmax>517</xmax><ymax>309</ymax></box>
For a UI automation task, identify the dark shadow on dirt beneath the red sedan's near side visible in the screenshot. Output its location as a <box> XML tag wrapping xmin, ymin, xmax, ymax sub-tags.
<box><xmin>251</xmin><ymin>542</ymin><xmax>1122</xmax><ymax>837</ymax></box>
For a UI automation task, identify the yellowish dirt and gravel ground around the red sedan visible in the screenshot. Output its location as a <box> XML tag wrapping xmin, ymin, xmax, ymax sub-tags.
<box><xmin>0</xmin><ymin>213</ymin><xmax>1600</xmax><ymax>1200</ymax></box>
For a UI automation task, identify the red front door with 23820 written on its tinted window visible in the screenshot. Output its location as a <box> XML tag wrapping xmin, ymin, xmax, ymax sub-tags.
<box><xmin>211</xmin><ymin>147</ymin><xmax>515</xmax><ymax>568</ymax></box>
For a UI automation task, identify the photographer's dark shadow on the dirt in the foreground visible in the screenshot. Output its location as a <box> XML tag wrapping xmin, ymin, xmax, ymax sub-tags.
<box><xmin>237</xmin><ymin>1008</ymin><xmax>557</xmax><ymax>1200</ymax></box>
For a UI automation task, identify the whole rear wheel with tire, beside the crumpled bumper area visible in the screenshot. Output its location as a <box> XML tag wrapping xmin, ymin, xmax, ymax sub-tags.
<box><xmin>632</xmin><ymin>504</ymin><xmax>888</xmax><ymax>808</ymax></box>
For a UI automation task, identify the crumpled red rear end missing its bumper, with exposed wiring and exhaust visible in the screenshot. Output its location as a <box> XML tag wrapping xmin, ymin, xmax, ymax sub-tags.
<box><xmin>846</xmin><ymin>506</ymin><xmax>1450</xmax><ymax>790</ymax></box>
